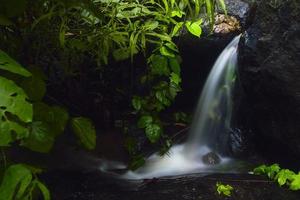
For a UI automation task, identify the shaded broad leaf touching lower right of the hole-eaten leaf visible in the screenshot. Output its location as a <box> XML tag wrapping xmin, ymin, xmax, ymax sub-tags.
<box><xmin>21</xmin><ymin>122</ymin><xmax>55</xmax><ymax>153</ymax></box>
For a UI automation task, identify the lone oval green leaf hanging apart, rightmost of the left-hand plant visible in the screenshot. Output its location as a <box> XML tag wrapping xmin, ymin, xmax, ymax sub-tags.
<box><xmin>71</xmin><ymin>117</ymin><xmax>96</xmax><ymax>150</ymax></box>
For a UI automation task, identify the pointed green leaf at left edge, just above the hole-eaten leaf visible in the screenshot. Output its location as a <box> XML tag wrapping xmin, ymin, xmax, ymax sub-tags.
<box><xmin>0</xmin><ymin>50</ymin><xmax>31</xmax><ymax>77</ymax></box>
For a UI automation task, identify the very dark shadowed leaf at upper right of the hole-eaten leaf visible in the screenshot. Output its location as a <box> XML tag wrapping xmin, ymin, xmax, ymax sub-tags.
<box><xmin>21</xmin><ymin>68</ymin><xmax>46</xmax><ymax>101</ymax></box>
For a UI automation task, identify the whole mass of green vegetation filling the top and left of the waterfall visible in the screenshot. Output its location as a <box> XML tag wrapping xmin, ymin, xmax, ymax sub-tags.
<box><xmin>0</xmin><ymin>0</ymin><xmax>225</xmax><ymax>200</ymax></box>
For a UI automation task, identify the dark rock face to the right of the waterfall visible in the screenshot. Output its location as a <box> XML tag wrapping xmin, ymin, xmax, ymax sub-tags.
<box><xmin>239</xmin><ymin>0</ymin><xmax>300</xmax><ymax>156</ymax></box>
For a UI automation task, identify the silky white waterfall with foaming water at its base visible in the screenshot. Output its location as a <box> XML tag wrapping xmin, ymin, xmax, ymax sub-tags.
<box><xmin>103</xmin><ymin>36</ymin><xmax>240</xmax><ymax>179</ymax></box>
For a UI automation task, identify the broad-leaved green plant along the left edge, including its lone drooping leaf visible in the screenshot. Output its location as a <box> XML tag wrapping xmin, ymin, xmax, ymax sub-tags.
<box><xmin>0</xmin><ymin>50</ymin><xmax>96</xmax><ymax>200</ymax></box>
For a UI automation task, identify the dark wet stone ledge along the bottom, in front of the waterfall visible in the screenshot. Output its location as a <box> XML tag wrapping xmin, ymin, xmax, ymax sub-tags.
<box><xmin>43</xmin><ymin>171</ymin><xmax>300</xmax><ymax>200</ymax></box>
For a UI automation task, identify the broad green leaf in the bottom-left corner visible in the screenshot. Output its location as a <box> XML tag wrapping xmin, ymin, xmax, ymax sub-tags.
<box><xmin>0</xmin><ymin>164</ymin><xmax>32</xmax><ymax>200</ymax></box>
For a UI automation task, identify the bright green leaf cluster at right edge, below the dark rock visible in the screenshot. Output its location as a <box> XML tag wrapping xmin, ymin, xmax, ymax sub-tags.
<box><xmin>253</xmin><ymin>164</ymin><xmax>300</xmax><ymax>190</ymax></box>
